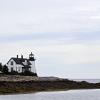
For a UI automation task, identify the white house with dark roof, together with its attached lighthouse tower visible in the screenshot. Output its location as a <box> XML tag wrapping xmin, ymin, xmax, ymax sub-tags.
<box><xmin>6</xmin><ymin>52</ymin><xmax>36</xmax><ymax>74</ymax></box>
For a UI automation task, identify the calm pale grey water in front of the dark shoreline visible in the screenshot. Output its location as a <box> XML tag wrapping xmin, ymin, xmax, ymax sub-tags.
<box><xmin>0</xmin><ymin>89</ymin><xmax>100</xmax><ymax>100</ymax></box>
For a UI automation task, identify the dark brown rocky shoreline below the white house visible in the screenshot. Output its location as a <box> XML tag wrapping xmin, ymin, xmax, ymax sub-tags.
<box><xmin>0</xmin><ymin>75</ymin><xmax>100</xmax><ymax>94</ymax></box>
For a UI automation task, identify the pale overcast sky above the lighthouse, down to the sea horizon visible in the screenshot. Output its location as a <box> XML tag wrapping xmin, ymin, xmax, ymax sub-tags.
<box><xmin>0</xmin><ymin>0</ymin><xmax>100</xmax><ymax>78</ymax></box>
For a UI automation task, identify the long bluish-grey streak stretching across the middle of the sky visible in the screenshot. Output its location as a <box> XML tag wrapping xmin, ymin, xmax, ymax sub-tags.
<box><xmin>0</xmin><ymin>32</ymin><xmax>100</xmax><ymax>43</ymax></box>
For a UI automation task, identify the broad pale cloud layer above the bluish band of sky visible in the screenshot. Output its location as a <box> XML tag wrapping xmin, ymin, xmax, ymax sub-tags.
<box><xmin>0</xmin><ymin>0</ymin><xmax>100</xmax><ymax>35</ymax></box>
